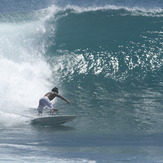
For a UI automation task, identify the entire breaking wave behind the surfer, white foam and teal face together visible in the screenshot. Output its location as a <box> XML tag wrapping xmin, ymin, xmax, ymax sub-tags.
<box><xmin>0</xmin><ymin>1</ymin><xmax>163</xmax><ymax>133</ymax></box>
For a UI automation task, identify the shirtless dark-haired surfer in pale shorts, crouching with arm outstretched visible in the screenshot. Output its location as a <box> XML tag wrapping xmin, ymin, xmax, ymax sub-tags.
<box><xmin>37</xmin><ymin>87</ymin><xmax>71</xmax><ymax>115</ymax></box>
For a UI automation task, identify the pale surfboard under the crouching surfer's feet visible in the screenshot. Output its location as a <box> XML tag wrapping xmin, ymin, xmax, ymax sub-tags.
<box><xmin>31</xmin><ymin>115</ymin><xmax>77</xmax><ymax>126</ymax></box>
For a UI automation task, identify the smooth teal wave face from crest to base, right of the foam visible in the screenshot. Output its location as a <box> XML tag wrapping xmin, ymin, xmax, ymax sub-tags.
<box><xmin>47</xmin><ymin>6</ymin><xmax>163</xmax><ymax>133</ymax></box>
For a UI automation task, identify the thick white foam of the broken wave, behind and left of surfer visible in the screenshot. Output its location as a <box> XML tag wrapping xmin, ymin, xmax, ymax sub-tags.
<box><xmin>0</xmin><ymin>11</ymin><xmax>54</xmax><ymax>125</ymax></box>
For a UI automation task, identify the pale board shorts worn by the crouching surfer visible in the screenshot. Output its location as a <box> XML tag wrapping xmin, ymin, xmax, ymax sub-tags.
<box><xmin>37</xmin><ymin>96</ymin><xmax>53</xmax><ymax>113</ymax></box>
